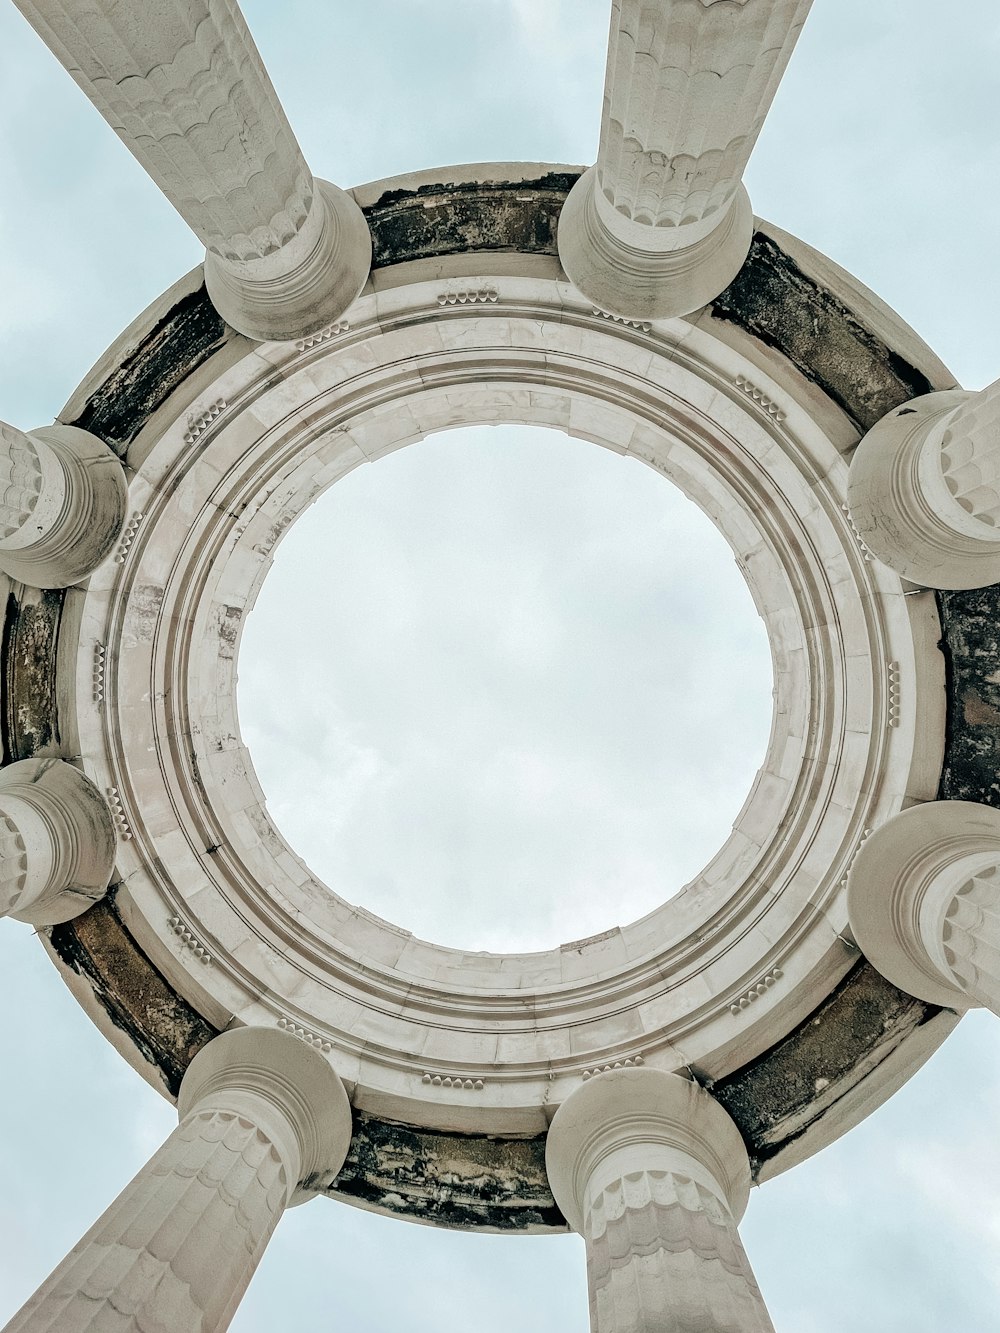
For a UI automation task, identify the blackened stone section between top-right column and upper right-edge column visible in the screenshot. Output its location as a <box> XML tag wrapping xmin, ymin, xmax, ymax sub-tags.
<box><xmin>712</xmin><ymin>232</ymin><xmax>933</xmax><ymax>431</ymax></box>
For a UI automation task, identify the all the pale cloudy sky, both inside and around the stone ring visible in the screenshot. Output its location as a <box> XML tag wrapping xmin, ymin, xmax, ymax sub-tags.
<box><xmin>0</xmin><ymin>0</ymin><xmax>1000</xmax><ymax>1333</ymax></box>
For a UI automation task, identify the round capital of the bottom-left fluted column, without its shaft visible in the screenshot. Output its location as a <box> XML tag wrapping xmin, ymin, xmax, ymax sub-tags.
<box><xmin>177</xmin><ymin>1028</ymin><xmax>352</xmax><ymax>1202</ymax></box>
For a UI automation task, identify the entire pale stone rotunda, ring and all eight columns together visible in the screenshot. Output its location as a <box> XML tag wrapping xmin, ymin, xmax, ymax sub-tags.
<box><xmin>0</xmin><ymin>0</ymin><xmax>1000</xmax><ymax>1333</ymax></box>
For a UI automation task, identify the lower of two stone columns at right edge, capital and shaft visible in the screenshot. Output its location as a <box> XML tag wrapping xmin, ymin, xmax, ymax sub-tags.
<box><xmin>848</xmin><ymin>801</ymin><xmax>1000</xmax><ymax>1014</ymax></box>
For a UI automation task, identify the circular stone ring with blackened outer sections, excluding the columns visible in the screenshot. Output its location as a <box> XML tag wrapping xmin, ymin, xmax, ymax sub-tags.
<box><xmin>0</xmin><ymin>167</ymin><xmax>970</xmax><ymax>1228</ymax></box>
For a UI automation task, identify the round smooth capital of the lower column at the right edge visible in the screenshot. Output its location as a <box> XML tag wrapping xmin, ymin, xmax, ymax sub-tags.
<box><xmin>848</xmin><ymin>801</ymin><xmax>1000</xmax><ymax>1009</ymax></box>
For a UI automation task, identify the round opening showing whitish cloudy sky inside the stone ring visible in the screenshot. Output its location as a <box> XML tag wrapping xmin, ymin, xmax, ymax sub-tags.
<box><xmin>239</xmin><ymin>427</ymin><xmax>772</xmax><ymax>952</ymax></box>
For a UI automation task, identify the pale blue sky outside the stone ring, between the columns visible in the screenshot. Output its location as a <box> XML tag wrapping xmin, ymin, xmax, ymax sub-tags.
<box><xmin>0</xmin><ymin>0</ymin><xmax>1000</xmax><ymax>1333</ymax></box>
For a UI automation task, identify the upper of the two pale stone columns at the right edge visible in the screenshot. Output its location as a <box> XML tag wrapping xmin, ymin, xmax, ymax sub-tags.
<box><xmin>848</xmin><ymin>380</ymin><xmax>1000</xmax><ymax>588</ymax></box>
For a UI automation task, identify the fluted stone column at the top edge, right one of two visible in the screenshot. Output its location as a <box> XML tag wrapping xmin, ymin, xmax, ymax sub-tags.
<box><xmin>559</xmin><ymin>0</ymin><xmax>812</xmax><ymax>320</ymax></box>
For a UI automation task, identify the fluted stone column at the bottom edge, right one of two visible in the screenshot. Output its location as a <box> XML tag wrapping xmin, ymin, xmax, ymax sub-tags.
<box><xmin>545</xmin><ymin>1068</ymin><xmax>773</xmax><ymax>1333</ymax></box>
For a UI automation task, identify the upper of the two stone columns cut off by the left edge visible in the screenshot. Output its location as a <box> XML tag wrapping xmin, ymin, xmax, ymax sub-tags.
<box><xmin>0</xmin><ymin>421</ymin><xmax>128</xmax><ymax>588</ymax></box>
